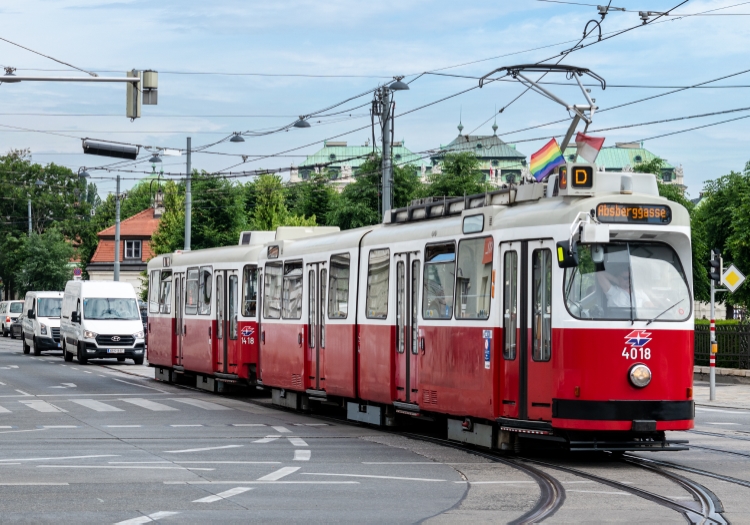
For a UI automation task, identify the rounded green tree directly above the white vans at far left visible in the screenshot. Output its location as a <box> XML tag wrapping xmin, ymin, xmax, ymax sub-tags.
<box><xmin>15</xmin><ymin>228</ymin><xmax>74</xmax><ymax>295</ymax></box>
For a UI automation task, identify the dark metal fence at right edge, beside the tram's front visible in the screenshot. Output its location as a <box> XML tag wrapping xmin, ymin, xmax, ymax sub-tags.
<box><xmin>695</xmin><ymin>323</ymin><xmax>750</xmax><ymax>370</ymax></box>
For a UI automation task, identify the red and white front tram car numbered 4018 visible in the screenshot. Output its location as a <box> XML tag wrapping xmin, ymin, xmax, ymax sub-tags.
<box><xmin>259</xmin><ymin>164</ymin><xmax>694</xmax><ymax>451</ymax></box>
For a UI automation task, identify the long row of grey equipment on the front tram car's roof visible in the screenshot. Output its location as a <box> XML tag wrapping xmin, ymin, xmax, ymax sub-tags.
<box><xmin>383</xmin><ymin>184</ymin><xmax>545</xmax><ymax>224</ymax></box>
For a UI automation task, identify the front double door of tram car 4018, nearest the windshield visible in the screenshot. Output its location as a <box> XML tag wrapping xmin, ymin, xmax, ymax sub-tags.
<box><xmin>500</xmin><ymin>240</ymin><xmax>553</xmax><ymax>421</ymax></box>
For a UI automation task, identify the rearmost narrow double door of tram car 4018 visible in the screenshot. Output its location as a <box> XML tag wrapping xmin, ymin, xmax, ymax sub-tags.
<box><xmin>305</xmin><ymin>262</ymin><xmax>328</xmax><ymax>390</ymax></box>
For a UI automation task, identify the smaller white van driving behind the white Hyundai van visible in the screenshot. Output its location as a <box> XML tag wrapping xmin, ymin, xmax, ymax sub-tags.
<box><xmin>21</xmin><ymin>292</ymin><xmax>63</xmax><ymax>355</ymax></box>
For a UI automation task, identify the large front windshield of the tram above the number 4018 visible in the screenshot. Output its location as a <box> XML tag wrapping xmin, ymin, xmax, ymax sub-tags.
<box><xmin>564</xmin><ymin>243</ymin><xmax>692</xmax><ymax>321</ymax></box>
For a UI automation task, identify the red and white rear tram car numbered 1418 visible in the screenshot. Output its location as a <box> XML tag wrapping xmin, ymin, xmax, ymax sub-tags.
<box><xmin>147</xmin><ymin>227</ymin><xmax>338</xmax><ymax>391</ymax></box>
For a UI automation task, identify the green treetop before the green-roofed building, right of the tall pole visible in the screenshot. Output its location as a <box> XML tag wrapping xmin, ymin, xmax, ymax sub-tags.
<box><xmin>423</xmin><ymin>151</ymin><xmax>492</xmax><ymax>201</ymax></box>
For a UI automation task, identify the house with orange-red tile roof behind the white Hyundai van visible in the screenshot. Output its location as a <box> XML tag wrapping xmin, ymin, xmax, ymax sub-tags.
<box><xmin>86</xmin><ymin>208</ymin><xmax>161</xmax><ymax>293</ymax></box>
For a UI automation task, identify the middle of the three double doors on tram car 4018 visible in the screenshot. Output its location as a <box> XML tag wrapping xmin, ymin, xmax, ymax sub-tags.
<box><xmin>393</xmin><ymin>252</ymin><xmax>422</xmax><ymax>404</ymax></box>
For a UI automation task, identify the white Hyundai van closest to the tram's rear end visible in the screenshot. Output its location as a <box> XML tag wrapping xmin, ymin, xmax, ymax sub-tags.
<box><xmin>60</xmin><ymin>281</ymin><xmax>146</xmax><ymax>365</ymax></box>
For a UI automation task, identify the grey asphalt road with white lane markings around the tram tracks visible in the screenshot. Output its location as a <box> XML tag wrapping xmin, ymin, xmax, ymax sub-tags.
<box><xmin>0</xmin><ymin>338</ymin><xmax>750</xmax><ymax>524</ymax></box>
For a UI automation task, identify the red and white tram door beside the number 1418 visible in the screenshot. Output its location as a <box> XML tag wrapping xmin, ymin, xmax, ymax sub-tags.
<box><xmin>214</xmin><ymin>270</ymin><xmax>239</xmax><ymax>374</ymax></box>
